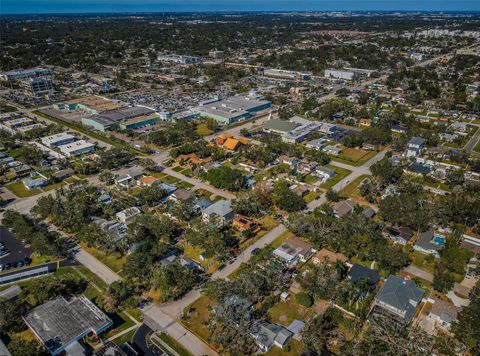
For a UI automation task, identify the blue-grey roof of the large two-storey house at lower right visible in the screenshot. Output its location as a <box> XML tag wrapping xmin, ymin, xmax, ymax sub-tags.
<box><xmin>375</xmin><ymin>275</ymin><xmax>424</xmax><ymax>322</ymax></box>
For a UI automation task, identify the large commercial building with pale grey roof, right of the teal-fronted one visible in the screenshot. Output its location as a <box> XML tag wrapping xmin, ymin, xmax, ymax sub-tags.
<box><xmin>193</xmin><ymin>93</ymin><xmax>272</xmax><ymax>125</ymax></box>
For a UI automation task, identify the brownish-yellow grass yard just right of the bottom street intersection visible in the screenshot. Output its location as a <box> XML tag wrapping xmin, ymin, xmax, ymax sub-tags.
<box><xmin>182</xmin><ymin>296</ymin><xmax>215</xmax><ymax>341</ymax></box>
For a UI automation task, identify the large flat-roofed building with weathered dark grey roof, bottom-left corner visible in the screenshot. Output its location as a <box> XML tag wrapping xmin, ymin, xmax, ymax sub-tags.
<box><xmin>23</xmin><ymin>295</ymin><xmax>113</xmax><ymax>355</ymax></box>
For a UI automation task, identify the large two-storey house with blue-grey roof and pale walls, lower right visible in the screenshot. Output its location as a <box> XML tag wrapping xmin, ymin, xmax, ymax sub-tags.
<box><xmin>372</xmin><ymin>275</ymin><xmax>424</xmax><ymax>324</ymax></box>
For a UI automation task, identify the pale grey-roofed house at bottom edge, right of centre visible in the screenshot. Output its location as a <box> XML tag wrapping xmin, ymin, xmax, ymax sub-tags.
<box><xmin>250</xmin><ymin>320</ymin><xmax>293</xmax><ymax>352</ymax></box>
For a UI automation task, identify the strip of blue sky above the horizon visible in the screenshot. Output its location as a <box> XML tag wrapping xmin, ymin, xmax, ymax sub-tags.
<box><xmin>0</xmin><ymin>0</ymin><xmax>480</xmax><ymax>15</ymax></box>
